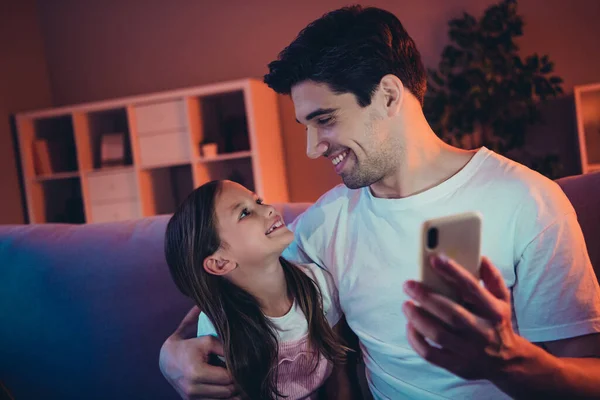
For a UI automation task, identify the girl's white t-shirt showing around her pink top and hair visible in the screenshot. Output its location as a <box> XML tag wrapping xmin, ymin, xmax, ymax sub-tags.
<box><xmin>197</xmin><ymin>264</ymin><xmax>342</xmax><ymax>343</ymax></box>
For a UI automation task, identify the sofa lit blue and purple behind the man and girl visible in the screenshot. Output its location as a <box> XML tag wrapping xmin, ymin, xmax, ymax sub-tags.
<box><xmin>0</xmin><ymin>173</ymin><xmax>600</xmax><ymax>400</ymax></box>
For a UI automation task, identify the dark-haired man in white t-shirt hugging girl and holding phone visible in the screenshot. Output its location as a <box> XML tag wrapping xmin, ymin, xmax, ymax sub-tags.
<box><xmin>161</xmin><ymin>7</ymin><xmax>600</xmax><ymax>399</ymax></box>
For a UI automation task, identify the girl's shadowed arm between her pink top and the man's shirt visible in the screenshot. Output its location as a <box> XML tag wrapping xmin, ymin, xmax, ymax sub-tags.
<box><xmin>321</xmin><ymin>318</ymin><xmax>363</xmax><ymax>400</ymax></box>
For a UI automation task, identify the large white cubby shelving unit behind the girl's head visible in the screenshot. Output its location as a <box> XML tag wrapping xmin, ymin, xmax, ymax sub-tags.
<box><xmin>16</xmin><ymin>79</ymin><xmax>288</xmax><ymax>223</ymax></box>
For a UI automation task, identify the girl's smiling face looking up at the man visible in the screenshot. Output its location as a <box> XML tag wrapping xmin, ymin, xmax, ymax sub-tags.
<box><xmin>215</xmin><ymin>181</ymin><xmax>294</xmax><ymax>266</ymax></box>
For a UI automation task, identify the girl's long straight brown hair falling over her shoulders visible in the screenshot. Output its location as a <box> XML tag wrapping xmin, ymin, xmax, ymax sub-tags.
<box><xmin>165</xmin><ymin>181</ymin><xmax>346</xmax><ymax>400</ymax></box>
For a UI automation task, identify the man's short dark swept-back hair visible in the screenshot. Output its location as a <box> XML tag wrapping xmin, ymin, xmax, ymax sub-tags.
<box><xmin>264</xmin><ymin>6</ymin><xmax>427</xmax><ymax>107</ymax></box>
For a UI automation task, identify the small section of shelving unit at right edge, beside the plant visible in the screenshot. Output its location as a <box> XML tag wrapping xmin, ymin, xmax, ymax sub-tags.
<box><xmin>573</xmin><ymin>83</ymin><xmax>600</xmax><ymax>174</ymax></box>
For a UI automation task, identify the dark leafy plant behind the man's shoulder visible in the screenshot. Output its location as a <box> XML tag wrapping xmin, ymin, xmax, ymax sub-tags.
<box><xmin>423</xmin><ymin>0</ymin><xmax>563</xmax><ymax>178</ymax></box>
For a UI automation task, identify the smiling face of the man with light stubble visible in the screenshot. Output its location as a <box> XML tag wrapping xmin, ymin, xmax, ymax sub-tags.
<box><xmin>291</xmin><ymin>81</ymin><xmax>401</xmax><ymax>189</ymax></box>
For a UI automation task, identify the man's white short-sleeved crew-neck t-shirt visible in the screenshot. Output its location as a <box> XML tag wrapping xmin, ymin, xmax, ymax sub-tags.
<box><xmin>283</xmin><ymin>148</ymin><xmax>600</xmax><ymax>399</ymax></box>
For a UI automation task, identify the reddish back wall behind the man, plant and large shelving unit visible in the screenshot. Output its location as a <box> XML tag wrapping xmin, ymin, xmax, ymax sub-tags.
<box><xmin>38</xmin><ymin>0</ymin><xmax>600</xmax><ymax>201</ymax></box>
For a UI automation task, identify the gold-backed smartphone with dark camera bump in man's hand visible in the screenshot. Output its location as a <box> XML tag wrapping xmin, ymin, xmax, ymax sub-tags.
<box><xmin>421</xmin><ymin>212</ymin><xmax>482</xmax><ymax>303</ymax></box>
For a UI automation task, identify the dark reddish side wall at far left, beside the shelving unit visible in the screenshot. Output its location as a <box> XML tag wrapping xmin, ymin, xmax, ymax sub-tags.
<box><xmin>0</xmin><ymin>0</ymin><xmax>51</xmax><ymax>224</ymax></box>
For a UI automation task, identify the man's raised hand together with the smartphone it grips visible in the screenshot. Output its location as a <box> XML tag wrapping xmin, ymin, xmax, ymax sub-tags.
<box><xmin>402</xmin><ymin>213</ymin><xmax>526</xmax><ymax>380</ymax></box>
